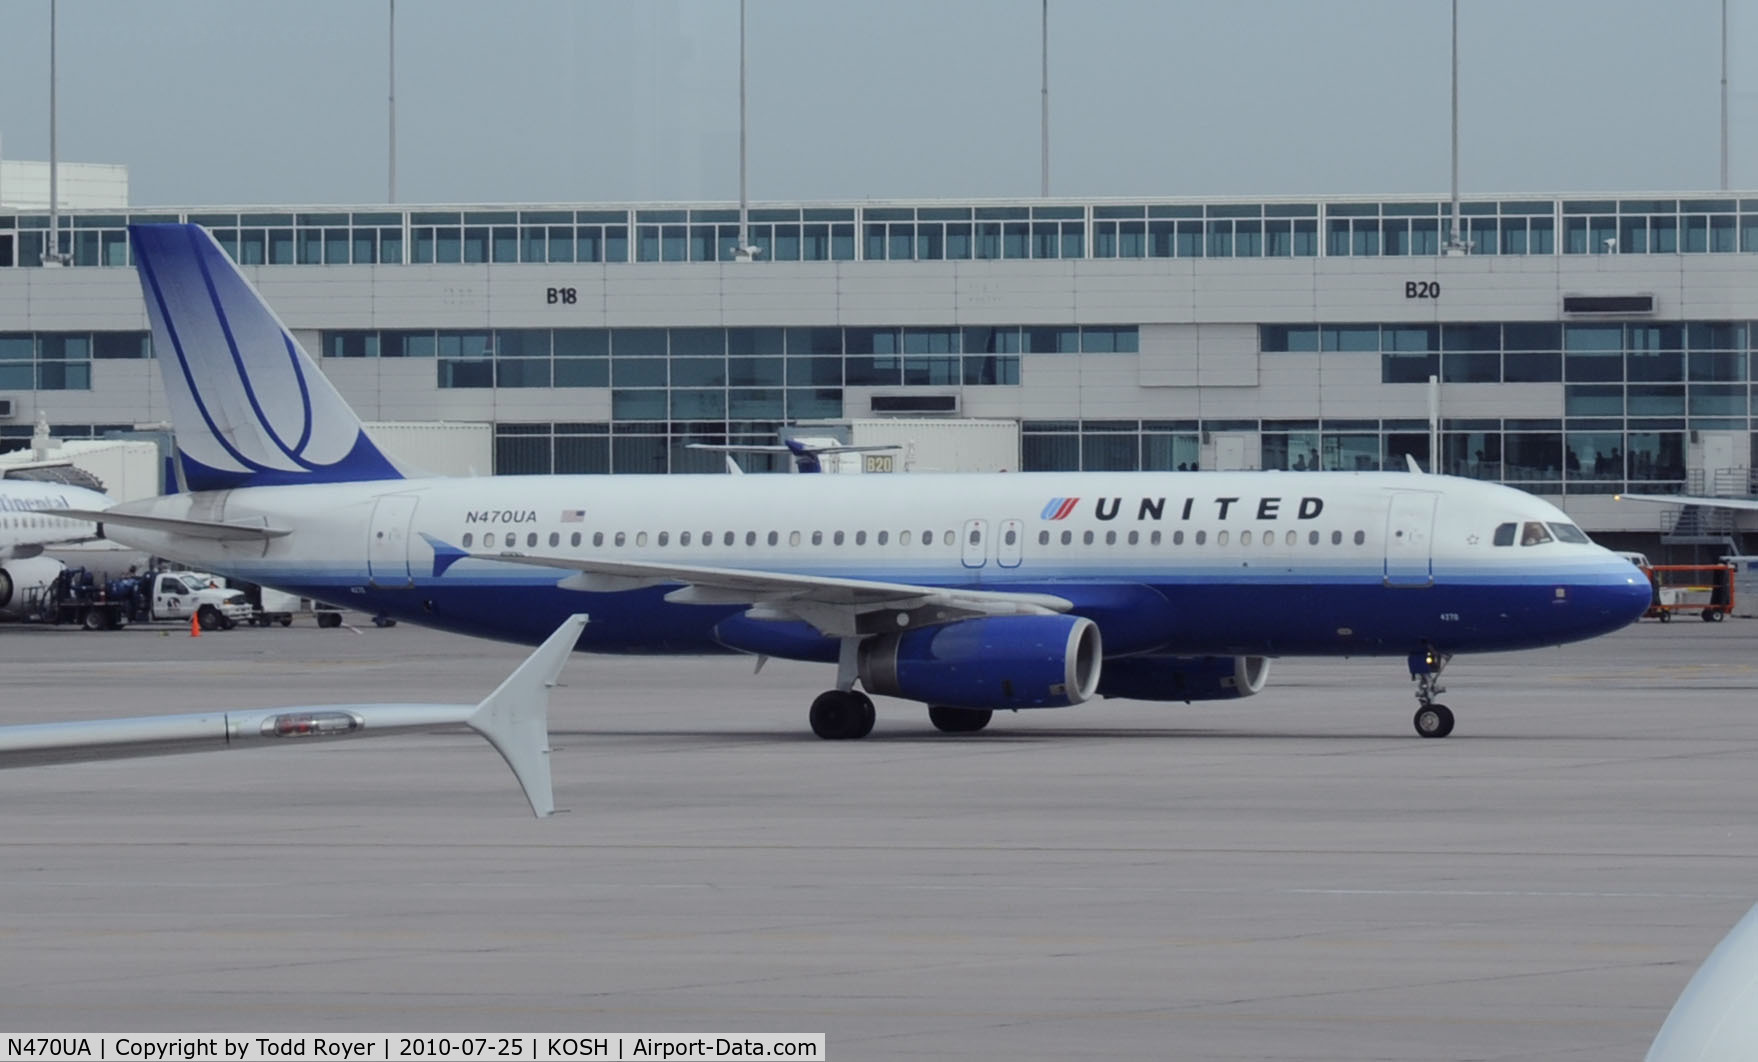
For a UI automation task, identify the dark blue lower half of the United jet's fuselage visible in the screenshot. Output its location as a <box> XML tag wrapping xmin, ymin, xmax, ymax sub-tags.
<box><xmin>219</xmin><ymin>561</ymin><xmax>1645</xmax><ymax>654</ymax></box>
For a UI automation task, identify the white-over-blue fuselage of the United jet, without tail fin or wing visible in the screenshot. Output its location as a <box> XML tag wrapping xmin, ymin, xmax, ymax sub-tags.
<box><xmin>111</xmin><ymin>473</ymin><xmax>1647</xmax><ymax>656</ymax></box>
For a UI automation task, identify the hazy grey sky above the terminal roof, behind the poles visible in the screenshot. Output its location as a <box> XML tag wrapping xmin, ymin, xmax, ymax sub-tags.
<box><xmin>0</xmin><ymin>0</ymin><xmax>1758</xmax><ymax>204</ymax></box>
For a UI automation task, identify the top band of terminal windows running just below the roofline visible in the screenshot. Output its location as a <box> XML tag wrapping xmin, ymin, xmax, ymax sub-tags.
<box><xmin>27</xmin><ymin>199</ymin><xmax>1758</xmax><ymax>267</ymax></box>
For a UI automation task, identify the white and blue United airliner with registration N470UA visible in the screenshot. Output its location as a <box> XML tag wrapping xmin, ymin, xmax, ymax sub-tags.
<box><xmin>72</xmin><ymin>225</ymin><xmax>1649</xmax><ymax>738</ymax></box>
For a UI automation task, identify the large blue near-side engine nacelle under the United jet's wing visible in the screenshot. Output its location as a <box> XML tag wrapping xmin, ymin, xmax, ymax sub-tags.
<box><xmin>860</xmin><ymin>615</ymin><xmax>1104</xmax><ymax>709</ymax></box>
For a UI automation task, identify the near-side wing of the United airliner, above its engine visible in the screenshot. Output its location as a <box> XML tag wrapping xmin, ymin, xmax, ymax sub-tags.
<box><xmin>446</xmin><ymin>538</ymin><xmax>1074</xmax><ymax>638</ymax></box>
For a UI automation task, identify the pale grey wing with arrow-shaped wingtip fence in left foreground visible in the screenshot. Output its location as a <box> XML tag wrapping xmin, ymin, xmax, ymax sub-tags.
<box><xmin>0</xmin><ymin>615</ymin><xmax>585</xmax><ymax>818</ymax></box>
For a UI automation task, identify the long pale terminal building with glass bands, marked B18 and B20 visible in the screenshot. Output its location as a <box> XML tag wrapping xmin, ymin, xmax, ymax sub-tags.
<box><xmin>0</xmin><ymin>193</ymin><xmax>1758</xmax><ymax>548</ymax></box>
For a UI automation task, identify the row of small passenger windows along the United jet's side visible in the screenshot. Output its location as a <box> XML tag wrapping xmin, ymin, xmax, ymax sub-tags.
<box><xmin>462</xmin><ymin>524</ymin><xmax>1371</xmax><ymax>549</ymax></box>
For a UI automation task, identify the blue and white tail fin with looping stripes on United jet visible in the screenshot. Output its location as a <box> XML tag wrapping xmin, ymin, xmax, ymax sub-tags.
<box><xmin>128</xmin><ymin>225</ymin><xmax>403</xmax><ymax>491</ymax></box>
